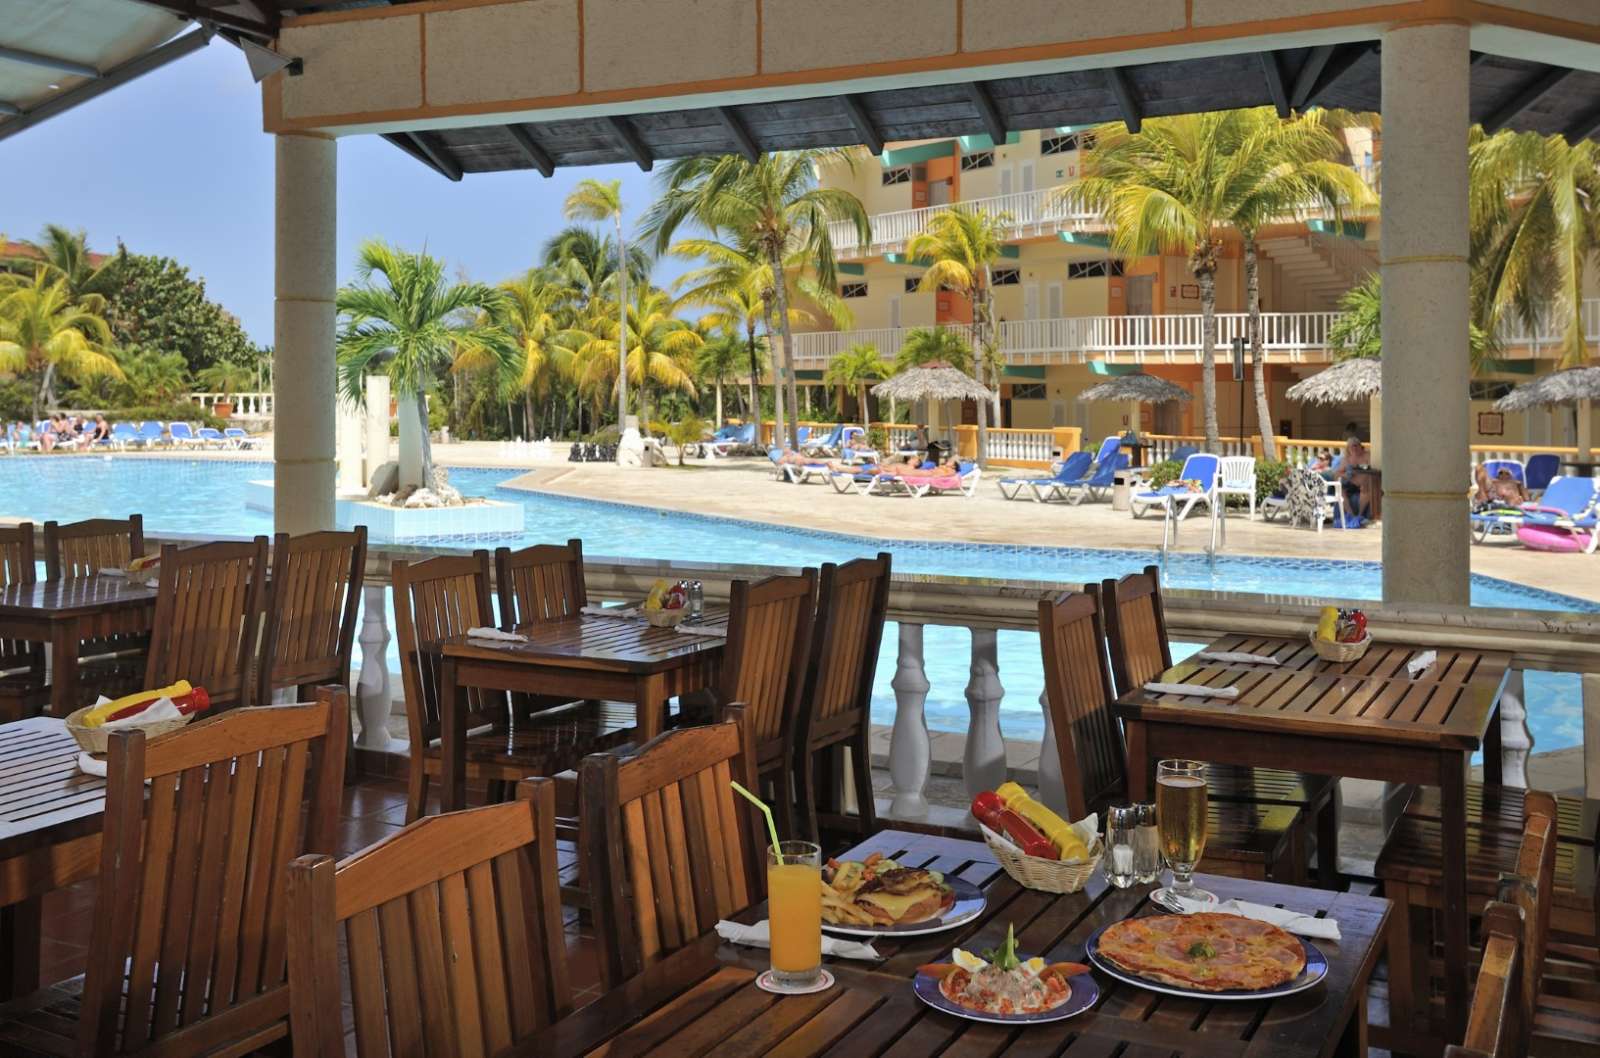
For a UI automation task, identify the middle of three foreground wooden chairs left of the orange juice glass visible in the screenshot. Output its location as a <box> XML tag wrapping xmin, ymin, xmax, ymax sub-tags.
<box><xmin>288</xmin><ymin>779</ymin><xmax>573</xmax><ymax>1058</ymax></box>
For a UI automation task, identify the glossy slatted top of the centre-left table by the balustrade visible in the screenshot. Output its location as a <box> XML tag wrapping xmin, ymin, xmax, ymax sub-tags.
<box><xmin>438</xmin><ymin>607</ymin><xmax>728</xmax><ymax>672</ymax></box>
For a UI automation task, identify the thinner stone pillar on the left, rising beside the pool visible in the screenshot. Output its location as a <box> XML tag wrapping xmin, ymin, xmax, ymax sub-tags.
<box><xmin>272</xmin><ymin>133</ymin><xmax>338</xmax><ymax>533</ymax></box>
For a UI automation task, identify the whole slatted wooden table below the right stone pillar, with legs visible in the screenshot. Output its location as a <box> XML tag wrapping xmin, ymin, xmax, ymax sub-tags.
<box><xmin>1114</xmin><ymin>635</ymin><xmax>1510</xmax><ymax>1039</ymax></box>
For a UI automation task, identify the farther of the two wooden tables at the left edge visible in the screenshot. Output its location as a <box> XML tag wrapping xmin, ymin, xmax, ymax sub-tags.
<box><xmin>0</xmin><ymin>575</ymin><xmax>157</xmax><ymax>715</ymax></box>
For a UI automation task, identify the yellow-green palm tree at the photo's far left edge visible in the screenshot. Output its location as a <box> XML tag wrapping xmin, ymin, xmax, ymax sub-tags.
<box><xmin>0</xmin><ymin>267</ymin><xmax>122</xmax><ymax>419</ymax></box>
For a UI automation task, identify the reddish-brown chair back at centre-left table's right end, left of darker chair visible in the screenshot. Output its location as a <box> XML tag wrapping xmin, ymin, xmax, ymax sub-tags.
<box><xmin>717</xmin><ymin>570</ymin><xmax>816</xmax><ymax>757</ymax></box>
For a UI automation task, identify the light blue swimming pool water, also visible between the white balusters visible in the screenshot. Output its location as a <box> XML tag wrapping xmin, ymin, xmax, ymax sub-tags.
<box><xmin>0</xmin><ymin>456</ymin><xmax>1600</xmax><ymax>749</ymax></box>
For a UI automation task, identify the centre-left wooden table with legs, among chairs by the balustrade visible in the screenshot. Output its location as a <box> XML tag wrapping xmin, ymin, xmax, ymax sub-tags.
<box><xmin>438</xmin><ymin>607</ymin><xmax>728</xmax><ymax>812</ymax></box>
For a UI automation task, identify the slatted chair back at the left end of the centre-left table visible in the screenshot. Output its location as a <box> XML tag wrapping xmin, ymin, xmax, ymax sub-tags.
<box><xmin>390</xmin><ymin>551</ymin><xmax>494</xmax><ymax>746</ymax></box>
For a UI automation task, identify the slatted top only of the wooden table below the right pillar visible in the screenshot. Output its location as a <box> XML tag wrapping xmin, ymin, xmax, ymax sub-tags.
<box><xmin>1115</xmin><ymin>635</ymin><xmax>1510</xmax><ymax>749</ymax></box>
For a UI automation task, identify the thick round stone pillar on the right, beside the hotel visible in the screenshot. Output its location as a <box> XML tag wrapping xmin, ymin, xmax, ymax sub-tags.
<box><xmin>1381</xmin><ymin>22</ymin><xmax>1470</xmax><ymax>605</ymax></box>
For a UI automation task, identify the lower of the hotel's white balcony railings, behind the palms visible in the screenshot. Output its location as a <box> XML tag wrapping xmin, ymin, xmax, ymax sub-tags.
<box><xmin>795</xmin><ymin>298</ymin><xmax>1600</xmax><ymax>368</ymax></box>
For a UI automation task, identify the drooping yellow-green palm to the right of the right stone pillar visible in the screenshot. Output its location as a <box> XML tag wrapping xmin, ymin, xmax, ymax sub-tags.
<box><xmin>1467</xmin><ymin>128</ymin><xmax>1600</xmax><ymax>368</ymax></box>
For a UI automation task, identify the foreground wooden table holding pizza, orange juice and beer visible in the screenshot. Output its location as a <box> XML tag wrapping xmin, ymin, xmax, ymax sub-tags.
<box><xmin>528</xmin><ymin>831</ymin><xmax>1389</xmax><ymax>1058</ymax></box>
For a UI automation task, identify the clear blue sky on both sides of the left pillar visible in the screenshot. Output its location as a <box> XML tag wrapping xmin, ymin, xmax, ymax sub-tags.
<box><xmin>0</xmin><ymin>38</ymin><xmax>683</xmax><ymax>346</ymax></box>
